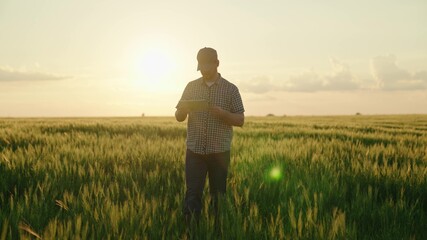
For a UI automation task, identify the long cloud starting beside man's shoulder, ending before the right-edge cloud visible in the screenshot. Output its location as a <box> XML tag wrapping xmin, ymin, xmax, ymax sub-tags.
<box><xmin>239</xmin><ymin>59</ymin><xmax>360</xmax><ymax>93</ymax></box>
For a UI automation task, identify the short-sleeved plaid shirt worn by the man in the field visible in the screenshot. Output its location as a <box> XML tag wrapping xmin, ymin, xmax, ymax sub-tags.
<box><xmin>176</xmin><ymin>75</ymin><xmax>245</xmax><ymax>154</ymax></box>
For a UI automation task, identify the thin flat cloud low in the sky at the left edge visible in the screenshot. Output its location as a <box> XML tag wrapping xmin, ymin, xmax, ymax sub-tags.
<box><xmin>0</xmin><ymin>66</ymin><xmax>70</xmax><ymax>82</ymax></box>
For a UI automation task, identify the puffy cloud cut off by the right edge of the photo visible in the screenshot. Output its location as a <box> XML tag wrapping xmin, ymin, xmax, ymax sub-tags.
<box><xmin>370</xmin><ymin>55</ymin><xmax>427</xmax><ymax>90</ymax></box>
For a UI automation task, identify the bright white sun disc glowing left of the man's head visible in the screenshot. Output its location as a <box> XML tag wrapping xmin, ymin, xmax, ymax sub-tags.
<box><xmin>135</xmin><ymin>47</ymin><xmax>175</xmax><ymax>91</ymax></box>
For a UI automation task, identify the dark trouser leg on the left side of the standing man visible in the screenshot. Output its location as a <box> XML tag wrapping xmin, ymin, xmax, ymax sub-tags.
<box><xmin>183</xmin><ymin>149</ymin><xmax>207</xmax><ymax>220</ymax></box>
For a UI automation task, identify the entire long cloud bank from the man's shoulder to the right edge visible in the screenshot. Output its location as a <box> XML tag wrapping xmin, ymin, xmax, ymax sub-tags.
<box><xmin>239</xmin><ymin>55</ymin><xmax>427</xmax><ymax>94</ymax></box>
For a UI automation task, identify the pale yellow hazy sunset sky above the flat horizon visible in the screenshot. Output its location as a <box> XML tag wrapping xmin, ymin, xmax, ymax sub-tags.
<box><xmin>0</xmin><ymin>0</ymin><xmax>427</xmax><ymax>117</ymax></box>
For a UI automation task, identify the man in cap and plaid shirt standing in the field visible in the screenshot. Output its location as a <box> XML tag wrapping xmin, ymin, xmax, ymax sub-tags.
<box><xmin>175</xmin><ymin>47</ymin><xmax>245</xmax><ymax>221</ymax></box>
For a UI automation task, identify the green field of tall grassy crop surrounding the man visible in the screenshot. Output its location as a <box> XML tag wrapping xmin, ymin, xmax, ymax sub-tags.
<box><xmin>0</xmin><ymin>115</ymin><xmax>427</xmax><ymax>240</ymax></box>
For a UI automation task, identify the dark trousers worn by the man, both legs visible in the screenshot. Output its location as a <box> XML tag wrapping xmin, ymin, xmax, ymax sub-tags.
<box><xmin>184</xmin><ymin>149</ymin><xmax>230</xmax><ymax>218</ymax></box>
